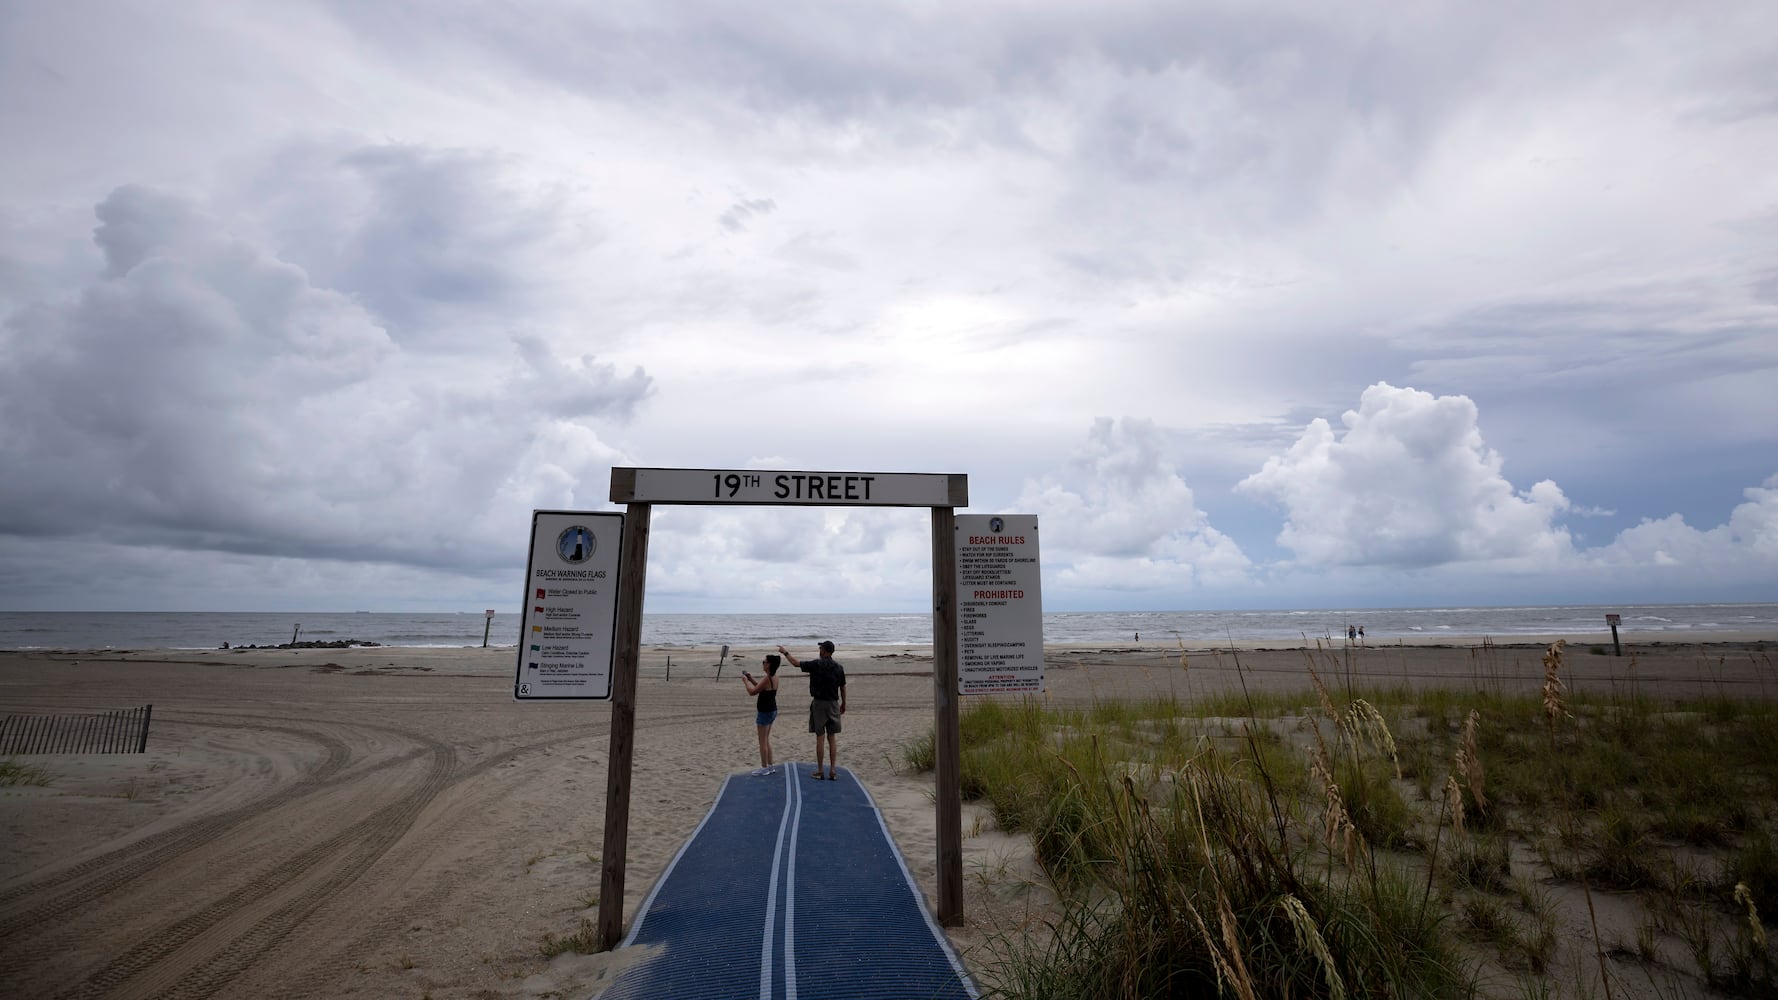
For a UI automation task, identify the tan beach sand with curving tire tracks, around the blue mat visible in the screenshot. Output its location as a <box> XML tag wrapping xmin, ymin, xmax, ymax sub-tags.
<box><xmin>0</xmin><ymin>635</ymin><xmax>1778</xmax><ymax>1000</ymax></box>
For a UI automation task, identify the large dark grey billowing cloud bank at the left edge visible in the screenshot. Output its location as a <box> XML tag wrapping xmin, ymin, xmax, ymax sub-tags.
<box><xmin>0</xmin><ymin>177</ymin><xmax>653</xmax><ymax>568</ymax></box>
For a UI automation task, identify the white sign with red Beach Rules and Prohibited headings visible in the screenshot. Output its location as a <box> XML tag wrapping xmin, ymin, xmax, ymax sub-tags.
<box><xmin>957</xmin><ymin>514</ymin><xmax>1044</xmax><ymax>694</ymax></box>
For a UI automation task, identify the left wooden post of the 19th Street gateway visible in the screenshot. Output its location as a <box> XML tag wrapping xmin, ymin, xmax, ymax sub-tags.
<box><xmin>597</xmin><ymin>504</ymin><xmax>651</xmax><ymax>952</ymax></box>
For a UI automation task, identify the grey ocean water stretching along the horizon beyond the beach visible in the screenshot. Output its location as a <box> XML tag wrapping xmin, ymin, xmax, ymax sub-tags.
<box><xmin>0</xmin><ymin>603</ymin><xmax>1778</xmax><ymax>649</ymax></box>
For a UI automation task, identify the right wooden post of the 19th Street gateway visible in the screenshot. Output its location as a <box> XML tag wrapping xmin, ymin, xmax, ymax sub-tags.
<box><xmin>932</xmin><ymin>507</ymin><xmax>964</xmax><ymax>927</ymax></box>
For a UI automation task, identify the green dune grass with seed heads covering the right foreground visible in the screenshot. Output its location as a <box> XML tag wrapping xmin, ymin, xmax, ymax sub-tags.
<box><xmin>907</xmin><ymin>644</ymin><xmax>1778</xmax><ymax>998</ymax></box>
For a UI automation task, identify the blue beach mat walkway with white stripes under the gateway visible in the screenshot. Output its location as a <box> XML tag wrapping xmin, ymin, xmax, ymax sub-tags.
<box><xmin>597</xmin><ymin>763</ymin><xmax>976</xmax><ymax>1000</ymax></box>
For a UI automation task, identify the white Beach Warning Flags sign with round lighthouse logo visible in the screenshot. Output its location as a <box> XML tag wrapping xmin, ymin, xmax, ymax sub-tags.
<box><xmin>512</xmin><ymin>511</ymin><xmax>624</xmax><ymax>701</ymax></box>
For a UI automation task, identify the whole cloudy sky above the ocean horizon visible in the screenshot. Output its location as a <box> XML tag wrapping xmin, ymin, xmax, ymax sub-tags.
<box><xmin>0</xmin><ymin>0</ymin><xmax>1778</xmax><ymax>612</ymax></box>
